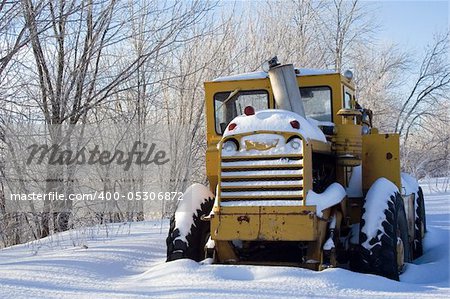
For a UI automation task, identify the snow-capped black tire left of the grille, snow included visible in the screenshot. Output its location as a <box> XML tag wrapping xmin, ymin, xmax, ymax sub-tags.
<box><xmin>166</xmin><ymin>184</ymin><xmax>214</xmax><ymax>262</ymax></box>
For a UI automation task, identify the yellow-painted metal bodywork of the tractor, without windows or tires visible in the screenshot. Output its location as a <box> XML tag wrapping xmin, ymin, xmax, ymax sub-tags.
<box><xmin>205</xmin><ymin>69</ymin><xmax>401</xmax><ymax>269</ymax></box>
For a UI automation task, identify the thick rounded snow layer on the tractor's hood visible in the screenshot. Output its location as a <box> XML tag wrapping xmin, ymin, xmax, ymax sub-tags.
<box><xmin>223</xmin><ymin>109</ymin><xmax>327</xmax><ymax>142</ymax></box>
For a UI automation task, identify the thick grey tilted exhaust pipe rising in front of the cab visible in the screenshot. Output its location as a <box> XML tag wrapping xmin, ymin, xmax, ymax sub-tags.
<box><xmin>269</xmin><ymin>56</ymin><xmax>306</xmax><ymax>118</ymax></box>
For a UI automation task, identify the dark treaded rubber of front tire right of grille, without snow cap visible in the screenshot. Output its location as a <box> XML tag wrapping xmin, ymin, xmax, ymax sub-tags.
<box><xmin>350</xmin><ymin>182</ymin><xmax>411</xmax><ymax>281</ymax></box>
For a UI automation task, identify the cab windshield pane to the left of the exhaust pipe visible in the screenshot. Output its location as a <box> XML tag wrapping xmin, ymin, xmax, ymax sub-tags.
<box><xmin>214</xmin><ymin>90</ymin><xmax>269</xmax><ymax>135</ymax></box>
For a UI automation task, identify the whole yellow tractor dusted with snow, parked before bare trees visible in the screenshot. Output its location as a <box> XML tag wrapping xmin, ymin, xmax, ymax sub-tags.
<box><xmin>167</xmin><ymin>58</ymin><xmax>426</xmax><ymax>280</ymax></box>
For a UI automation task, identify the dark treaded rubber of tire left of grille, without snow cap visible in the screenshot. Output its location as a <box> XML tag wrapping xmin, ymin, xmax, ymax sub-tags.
<box><xmin>166</xmin><ymin>187</ymin><xmax>214</xmax><ymax>262</ymax></box>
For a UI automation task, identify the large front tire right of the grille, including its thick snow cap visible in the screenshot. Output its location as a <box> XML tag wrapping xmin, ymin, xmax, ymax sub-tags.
<box><xmin>351</xmin><ymin>178</ymin><xmax>411</xmax><ymax>280</ymax></box>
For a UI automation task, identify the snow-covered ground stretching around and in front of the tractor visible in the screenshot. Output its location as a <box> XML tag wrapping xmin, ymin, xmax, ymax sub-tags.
<box><xmin>0</xmin><ymin>181</ymin><xmax>450</xmax><ymax>298</ymax></box>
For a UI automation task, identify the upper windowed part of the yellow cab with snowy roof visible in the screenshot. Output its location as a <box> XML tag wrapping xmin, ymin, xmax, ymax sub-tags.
<box><xmin>205</xmin><ymin>69</ymin><xmax>355</xmax><ymax>135</ymax></box>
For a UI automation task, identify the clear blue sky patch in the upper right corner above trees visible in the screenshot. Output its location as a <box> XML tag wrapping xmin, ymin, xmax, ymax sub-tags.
<box><xmin>370</xmin><ymin>0</ymin><xmax>450</xmax><ymax>52</ymax></box>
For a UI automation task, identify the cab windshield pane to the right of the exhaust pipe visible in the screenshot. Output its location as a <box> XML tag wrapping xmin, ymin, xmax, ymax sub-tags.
<box><xmin>300</xmin><ymin>86</ymin><xmax>333</xmax><ymax>122</ymax></box>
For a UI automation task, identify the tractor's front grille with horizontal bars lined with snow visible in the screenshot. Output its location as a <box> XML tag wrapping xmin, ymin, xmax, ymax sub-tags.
<box><xmin>220</xmin><ymin>154</ymin><xmax>303</xmax><ymax>202</ymax></box>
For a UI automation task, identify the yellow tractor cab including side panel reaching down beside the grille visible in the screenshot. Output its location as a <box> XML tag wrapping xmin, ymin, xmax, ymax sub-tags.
<box><xmin>205</xmin><ymin>68</ymin><xmax>357</xmax><ymax>190</ymax></box>
